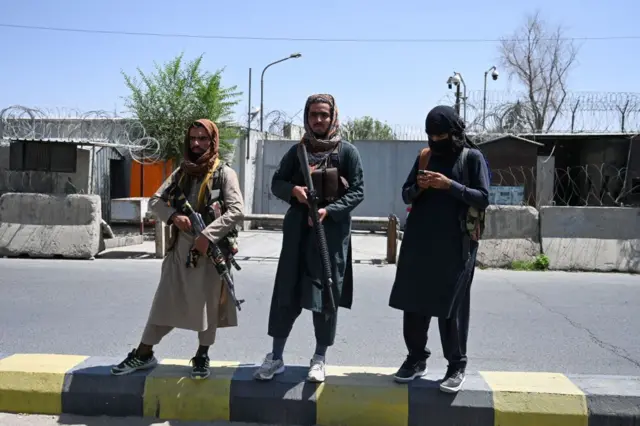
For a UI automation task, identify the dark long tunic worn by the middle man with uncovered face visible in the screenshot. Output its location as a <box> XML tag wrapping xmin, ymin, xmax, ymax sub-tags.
<box><xmin>271</xmin><ymin>141</ymin><xmax>364</xmax><ymax>312</ymax></box>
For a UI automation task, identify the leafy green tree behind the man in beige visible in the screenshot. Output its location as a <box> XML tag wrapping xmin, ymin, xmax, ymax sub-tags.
<box><xmin>122</xmin><ymin>53</ymin><xmax>242</xmax><ymax>162</ymax></box>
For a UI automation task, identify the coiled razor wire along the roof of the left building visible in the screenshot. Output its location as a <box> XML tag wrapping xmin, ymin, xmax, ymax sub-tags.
<box><xmin>0</xmin><ymin>105</ymin><xmax>162</xmax><ymax>164</ymax></box>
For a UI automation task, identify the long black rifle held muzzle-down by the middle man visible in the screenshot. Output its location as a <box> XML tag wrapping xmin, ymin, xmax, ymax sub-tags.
<box><xmin>298</xmin><ymin>143</ymin><xmax>336</xmax><ymax>312</ymax></box>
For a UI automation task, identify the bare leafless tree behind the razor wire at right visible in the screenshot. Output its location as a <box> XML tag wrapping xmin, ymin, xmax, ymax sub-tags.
<box><xmin>499</xmin><ymin>12</ymin><xmax>578</xmax><ymax>132</ymax></box>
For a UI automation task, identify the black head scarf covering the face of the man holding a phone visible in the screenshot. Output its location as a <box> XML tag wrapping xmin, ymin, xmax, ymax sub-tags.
<box><xmin>425</xmin><ymin>105</ymin><xmax>477</xmax><ymax>153</ymax></box>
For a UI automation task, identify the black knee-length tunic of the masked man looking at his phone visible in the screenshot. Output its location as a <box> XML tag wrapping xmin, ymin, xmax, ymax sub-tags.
<box><xmin>389</xmin><ymin>149</ymin><xmax>489</xmax><ymax>318</ymax></box>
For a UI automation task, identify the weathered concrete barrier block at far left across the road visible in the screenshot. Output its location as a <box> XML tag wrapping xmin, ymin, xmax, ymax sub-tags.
<box><xmin>0</xmin><ymin>193</ymin><xmax>102</xmax><ymax>259</ymax></box>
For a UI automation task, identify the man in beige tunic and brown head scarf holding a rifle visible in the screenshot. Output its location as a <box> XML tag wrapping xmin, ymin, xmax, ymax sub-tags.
<box><xmin>111</xmin><ymin>119</ymin><xmax>244</xmax><ymax>378</ymax></box>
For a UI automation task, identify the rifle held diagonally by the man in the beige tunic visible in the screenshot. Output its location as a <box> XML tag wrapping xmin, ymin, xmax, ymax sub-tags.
<box><xmin>177</xmin><ymin>188</ymin><xmax>244</xmax><ymax>311</ymax></box>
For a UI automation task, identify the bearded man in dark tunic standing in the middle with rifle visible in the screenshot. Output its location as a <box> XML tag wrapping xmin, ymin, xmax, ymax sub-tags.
<box><xmin>254</xmin><ymin>94</ymin><xmax>364</xmax><ymax>382</ymax></box>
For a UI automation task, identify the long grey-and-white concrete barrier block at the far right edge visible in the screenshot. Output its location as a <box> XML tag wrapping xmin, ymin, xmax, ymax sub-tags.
<box><xmin>540</xmin><ymin>207</ymin><xmax>640</xmax><ymax>273</ymax></box>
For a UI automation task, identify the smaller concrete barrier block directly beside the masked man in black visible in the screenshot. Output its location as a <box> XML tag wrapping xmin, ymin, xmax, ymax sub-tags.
<box><xmin>477</xmin><ymin>205</ymin><xmax>540</xmax><ymax>268</ymax></box>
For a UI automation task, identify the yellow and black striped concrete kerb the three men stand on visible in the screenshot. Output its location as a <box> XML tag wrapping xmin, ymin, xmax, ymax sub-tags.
<box><xmin>0</xmin><ymin>354</ymin><xmax>640</xmax><ymax>426</ymax></box>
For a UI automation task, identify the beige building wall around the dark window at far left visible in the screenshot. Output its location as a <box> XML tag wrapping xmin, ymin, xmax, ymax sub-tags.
<box><xmin>0</xmin><ymin>145</ymin><xmax>91</xmax><ymax>194</ymax></box>
